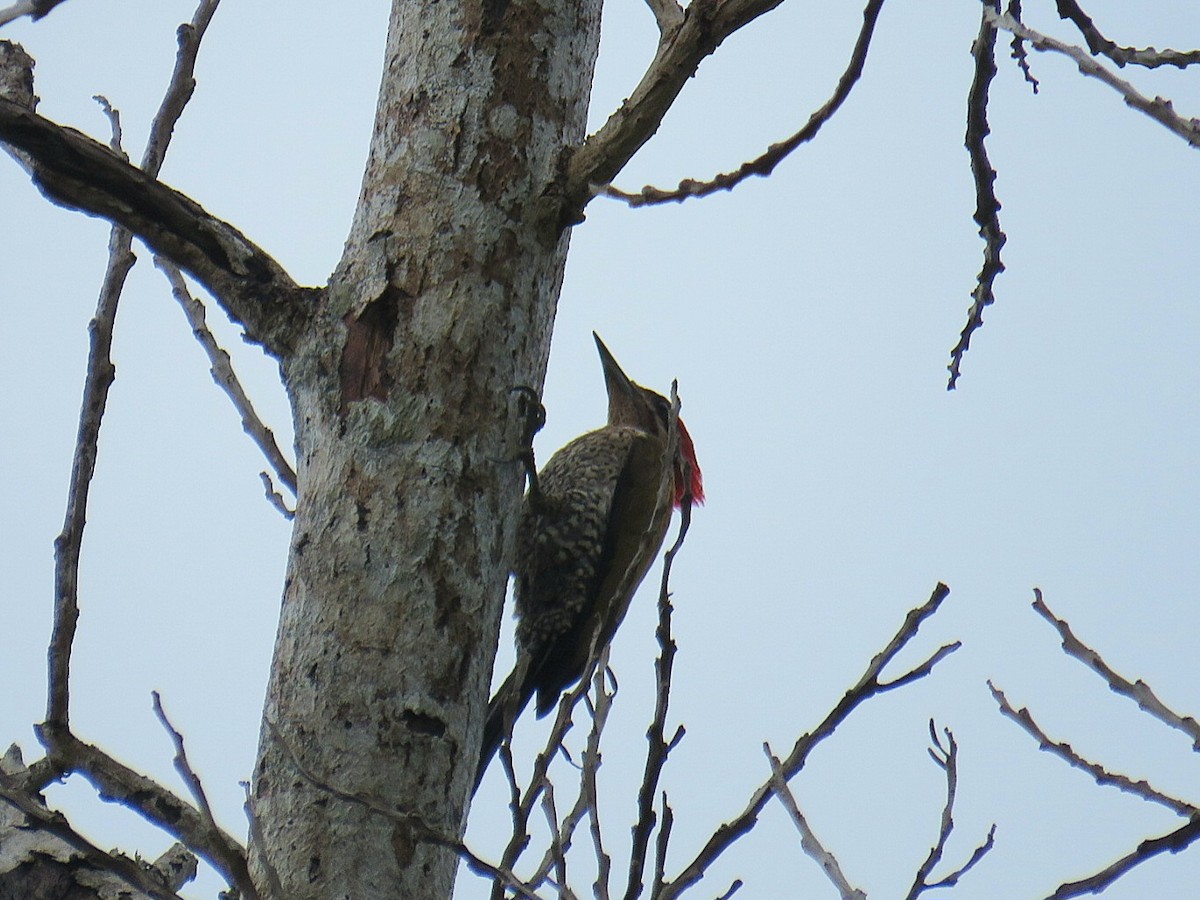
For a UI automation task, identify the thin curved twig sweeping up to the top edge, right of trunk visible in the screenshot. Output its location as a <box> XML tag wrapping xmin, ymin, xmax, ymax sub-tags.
<box><xmin>599</xmin><ymin>0</ymin><xmax>883</xmax><ymax>206</ymax></box>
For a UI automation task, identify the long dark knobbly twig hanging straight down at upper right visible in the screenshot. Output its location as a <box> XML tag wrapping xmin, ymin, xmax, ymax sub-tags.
<box><xmin>946</xmin><ymin>0</ymin><xmax>1007</xmax><ymax>390</ymax></box>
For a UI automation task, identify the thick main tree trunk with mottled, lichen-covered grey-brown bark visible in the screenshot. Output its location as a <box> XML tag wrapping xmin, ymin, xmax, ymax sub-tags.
<box><xmin>253</xmin><ymin>0</ymin><xmax>600</xmax><ymax>900</ymax></box>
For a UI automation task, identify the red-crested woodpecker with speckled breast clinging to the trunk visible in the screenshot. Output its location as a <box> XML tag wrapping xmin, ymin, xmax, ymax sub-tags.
<box><xmin>475</xmin><ymin>332</ymin><xmax>704</xmax><ymax>787</ymax></box>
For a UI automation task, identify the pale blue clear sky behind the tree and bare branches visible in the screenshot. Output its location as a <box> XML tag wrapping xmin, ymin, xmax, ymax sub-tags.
<box><xmin>0</xmin><ymin>0</ymin><xmax>1200</xmax><ymax>900</ymax></box>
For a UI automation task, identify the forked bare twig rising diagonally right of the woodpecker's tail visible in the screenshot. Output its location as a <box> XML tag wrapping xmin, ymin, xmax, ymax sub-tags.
<box><xmin>660</xmin><ymin>584</ymin><xmax>958</xmax><ymax>900</ymax></box>
